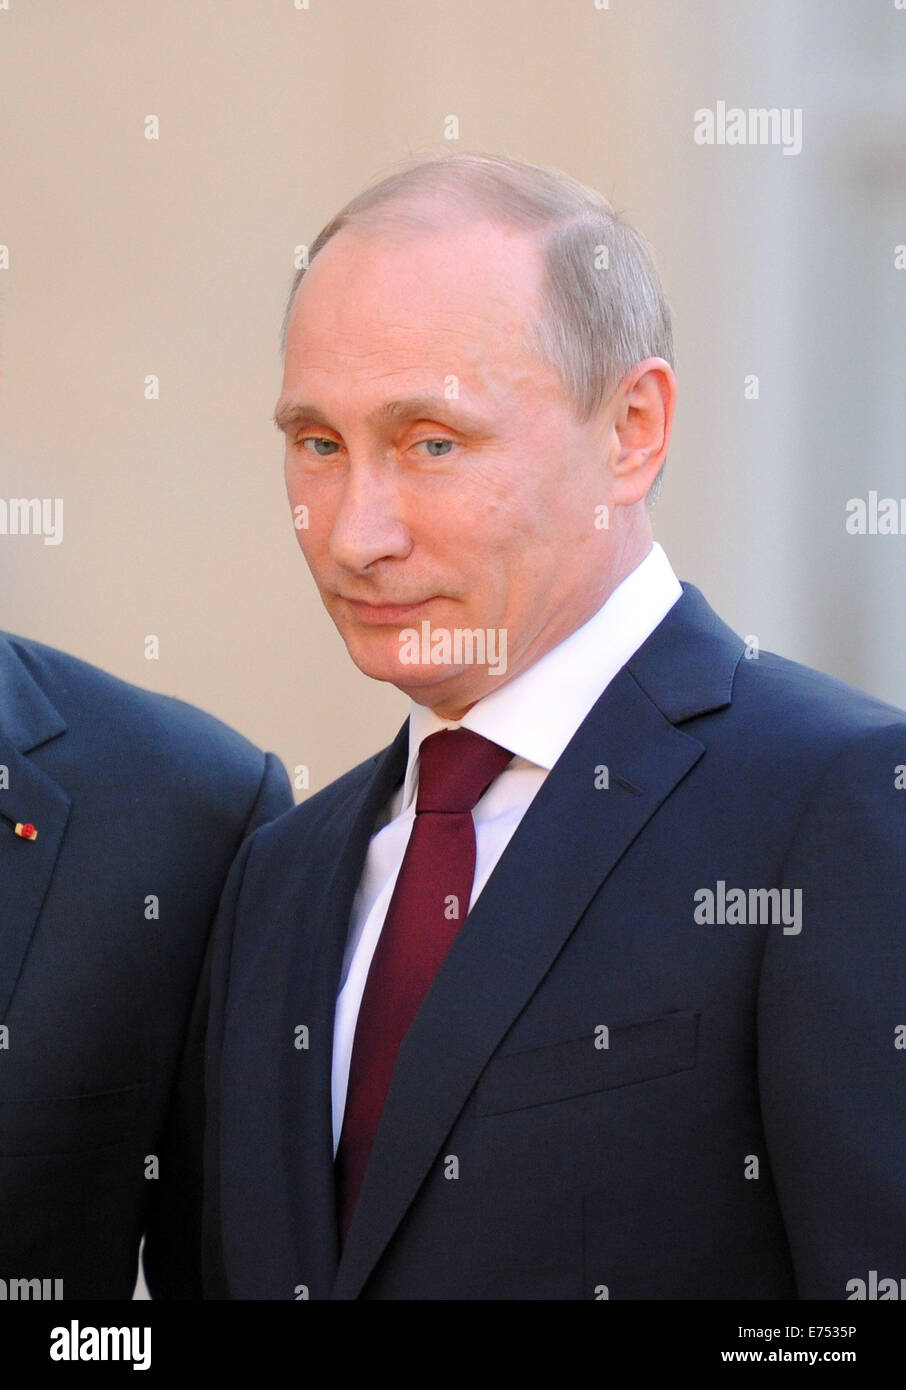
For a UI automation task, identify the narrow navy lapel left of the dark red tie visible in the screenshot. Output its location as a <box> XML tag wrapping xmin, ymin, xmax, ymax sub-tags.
<box><xmin>279</xmin><ymin>720</ymin><xmax>409</xmax><ymax>1298</ymax></box>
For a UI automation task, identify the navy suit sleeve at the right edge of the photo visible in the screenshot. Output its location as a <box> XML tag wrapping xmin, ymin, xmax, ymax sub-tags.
<box><xmin>757</xmin><ymin>724</ymin><xmax>906</xmax><ymax>1300</ymax></box>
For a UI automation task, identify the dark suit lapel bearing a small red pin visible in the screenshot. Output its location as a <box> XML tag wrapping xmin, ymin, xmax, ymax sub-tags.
<box><xmin>0</xmin><ymin>638</ymin><xmax>69</xmax><ymax>1020</ymax></box>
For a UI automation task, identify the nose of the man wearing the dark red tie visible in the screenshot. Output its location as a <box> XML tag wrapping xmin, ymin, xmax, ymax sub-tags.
<box><xmin>331</xmin><ymin>463</ymin><xmax>411</xmax><ymax>573</ymax></box>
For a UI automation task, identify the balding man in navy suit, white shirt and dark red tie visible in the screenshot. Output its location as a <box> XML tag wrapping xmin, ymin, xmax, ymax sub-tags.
<box><xmin>206</xmin><ymin>156</ymin><xmax>906</xmax><ymax>1300</ymax></box>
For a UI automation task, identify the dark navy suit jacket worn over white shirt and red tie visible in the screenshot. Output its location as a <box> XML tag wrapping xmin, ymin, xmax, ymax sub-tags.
<box><xmin>206</xmin><ymin>585</ymin><xmax>906</xmax><ymax>1300</ymax></box>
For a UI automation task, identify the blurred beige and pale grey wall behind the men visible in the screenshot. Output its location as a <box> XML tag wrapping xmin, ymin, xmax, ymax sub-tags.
<box><xmin>0</xmin><ymin>0</ymin><xmax>906</xmax><ymax>787</ymax></box>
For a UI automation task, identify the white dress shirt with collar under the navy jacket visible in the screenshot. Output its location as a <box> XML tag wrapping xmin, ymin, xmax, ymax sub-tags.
<box><xmin>332</xmin><ymin>542</ymin><xmax>682</xmax><ymax>1152</ymax></box>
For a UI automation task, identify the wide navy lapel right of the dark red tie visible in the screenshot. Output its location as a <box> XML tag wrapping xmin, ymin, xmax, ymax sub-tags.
<box><xmin>331</xmin><ymin>588</ymin><xmax>742</xmax><ymax>1298</ymax></box>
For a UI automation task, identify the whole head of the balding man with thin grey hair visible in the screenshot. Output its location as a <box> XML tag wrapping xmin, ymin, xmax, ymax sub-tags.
<box><xmin>277</xmin><ymin>156</ymin><xmax>675</xmax><ymax>717</ymax></box>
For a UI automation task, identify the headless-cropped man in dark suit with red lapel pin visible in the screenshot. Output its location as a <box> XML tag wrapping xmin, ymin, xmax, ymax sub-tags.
<box><xmin>0</xmin><ymin>635</ymin><xmax>292</xmax><ymax>1300</ymax></box>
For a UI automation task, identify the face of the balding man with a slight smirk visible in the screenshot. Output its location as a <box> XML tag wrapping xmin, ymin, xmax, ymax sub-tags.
<box><xmin>277</xmin><ymin>222</ymin><xmax>614</xmax><ymax>717</ymax></box>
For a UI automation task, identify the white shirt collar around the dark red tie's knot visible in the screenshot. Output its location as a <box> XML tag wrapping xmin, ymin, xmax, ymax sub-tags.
<box><xmin>402</xmin><ymin>542</ymin><xmax>682</xmax><ymax>808</ymax></box>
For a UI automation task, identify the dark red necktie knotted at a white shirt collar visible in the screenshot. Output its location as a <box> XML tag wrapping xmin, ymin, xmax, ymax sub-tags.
<box><xmin>335</xmin><ymin>728</ymin><xmax>513</xmax><ymax>1240</ymax></box>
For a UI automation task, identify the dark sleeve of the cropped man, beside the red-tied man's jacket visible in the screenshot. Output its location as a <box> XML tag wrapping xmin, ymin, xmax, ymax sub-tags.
<box><xmin>142</xmin><ymin>753</ymin><xmax>293</xmax><ymax>1300</ymax></box>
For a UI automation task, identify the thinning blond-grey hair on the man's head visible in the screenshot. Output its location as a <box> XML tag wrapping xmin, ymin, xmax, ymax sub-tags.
<box><xmin>282</xmin><ymin>154</ymin><xmax>674</xmax><ymax>500</ymax></box>
